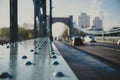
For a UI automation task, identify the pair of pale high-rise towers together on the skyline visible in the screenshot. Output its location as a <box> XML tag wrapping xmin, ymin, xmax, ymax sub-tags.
<box><xmin>77</xmin><ymin>12</ymin><xmax>103</xmax><ymax>30</ymax></box>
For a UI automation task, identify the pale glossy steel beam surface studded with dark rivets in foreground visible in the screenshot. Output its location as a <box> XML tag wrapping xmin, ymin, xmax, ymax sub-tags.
<box><xmin>0</xmin><ymin>38</ymin><xmax>78</xmax><ymax>80</ymax></box>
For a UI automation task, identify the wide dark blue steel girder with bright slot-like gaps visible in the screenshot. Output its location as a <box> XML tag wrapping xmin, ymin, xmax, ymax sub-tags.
<box><xmin>33</xmin><ymin>0</ymin><xmax>46</xmax><ymax>36</ymax></box>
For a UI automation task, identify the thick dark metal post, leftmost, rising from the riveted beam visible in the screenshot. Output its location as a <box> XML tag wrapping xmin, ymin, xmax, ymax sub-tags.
<box><xmin>10</xmin><ymin>0</ymin><xmax>18</xmax><ymax>42</ymax></box>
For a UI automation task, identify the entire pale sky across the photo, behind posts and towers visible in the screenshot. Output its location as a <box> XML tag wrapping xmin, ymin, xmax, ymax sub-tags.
<box><xmin>0</xmin><ymin>0</ymin><xmax>120</xmax><ymax>33</ymax></box>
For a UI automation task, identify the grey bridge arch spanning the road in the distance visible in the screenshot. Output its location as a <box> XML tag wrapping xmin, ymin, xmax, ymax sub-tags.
<box><xmin>52</xmin><ymin>16</ymin><xmax>74</xmax><ymax>37</ymax></box>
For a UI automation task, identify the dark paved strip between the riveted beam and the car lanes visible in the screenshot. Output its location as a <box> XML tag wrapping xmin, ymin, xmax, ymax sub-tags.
<box><xmin>55</xmin><ymin>41</ymin><xmax>120</xmax><ymax>80</ymax></box>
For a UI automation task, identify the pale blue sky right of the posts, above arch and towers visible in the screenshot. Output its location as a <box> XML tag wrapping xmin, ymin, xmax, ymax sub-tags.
<box><xmin>53</xmin><ymin>0</ymin><xmax>120</xmax><ymax>30</ymax></box>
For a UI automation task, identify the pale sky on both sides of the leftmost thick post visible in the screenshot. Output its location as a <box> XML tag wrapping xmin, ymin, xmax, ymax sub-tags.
<box><xmin>0</xmin><ymin>0</ymin><xmax>34</xmax><ymax>27</ymax></box>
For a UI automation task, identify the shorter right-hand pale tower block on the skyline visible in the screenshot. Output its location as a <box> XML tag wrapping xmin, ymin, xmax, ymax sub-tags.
<box><xmin>92</xmin><ymin>17</ymin><xmax>102</xmax><ymax>31</ymax></box>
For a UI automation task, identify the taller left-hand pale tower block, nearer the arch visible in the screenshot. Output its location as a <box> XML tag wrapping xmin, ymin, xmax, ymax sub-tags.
<box><xmin>78</xmin><ymin>13</ymin><xmax>90</xmax><ymax>28</ymax></box>
